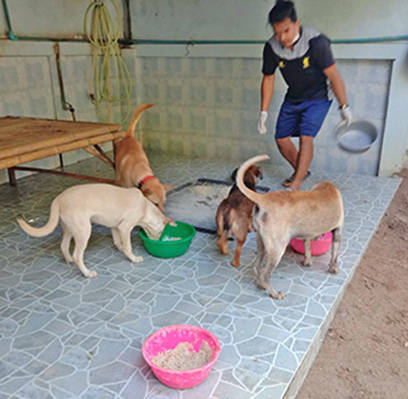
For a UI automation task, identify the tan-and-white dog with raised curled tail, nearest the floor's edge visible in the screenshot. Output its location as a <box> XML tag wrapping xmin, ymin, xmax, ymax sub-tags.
<box><xmin>237</xmin><ymin>155</ymin><xmax>344</xmax><ymax>299</ymax></box>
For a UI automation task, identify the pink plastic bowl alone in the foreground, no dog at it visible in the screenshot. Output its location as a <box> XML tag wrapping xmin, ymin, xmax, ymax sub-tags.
<box><xmin>142</xmin><ymin>324</ymin><xmax>221</xmax><ymax>389</ymax></box>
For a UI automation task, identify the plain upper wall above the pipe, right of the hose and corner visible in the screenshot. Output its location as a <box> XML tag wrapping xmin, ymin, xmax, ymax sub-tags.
<box><xmin>131</xmin><ymin>0</ymin><xmax>408</xmax><ymax>40</ymax></box>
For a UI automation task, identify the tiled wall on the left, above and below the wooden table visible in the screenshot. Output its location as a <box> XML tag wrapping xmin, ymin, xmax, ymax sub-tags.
<box><xmin>0</xmin><ymin>56</ymin><xmax>121</xmax><ymax>183</ymax></box>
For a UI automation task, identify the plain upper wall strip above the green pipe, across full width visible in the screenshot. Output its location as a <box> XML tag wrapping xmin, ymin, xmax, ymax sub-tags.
<box><xmin>0</xmin><ymin>0</ymin><xmax>408</xmax><ymax>40</ymax></box>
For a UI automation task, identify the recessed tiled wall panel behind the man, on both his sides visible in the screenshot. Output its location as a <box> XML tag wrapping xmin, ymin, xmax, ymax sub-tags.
<box><xmin>133</xmin><ymin>57</ymin><xmax>391</xmax><ymax>175</ymax></box>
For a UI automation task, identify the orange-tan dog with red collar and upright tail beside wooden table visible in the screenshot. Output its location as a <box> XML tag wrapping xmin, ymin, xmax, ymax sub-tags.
<box><xmin>115</xmin><ymin>104</ymin><xmax>172</xmax><ymax>212</ymax></box>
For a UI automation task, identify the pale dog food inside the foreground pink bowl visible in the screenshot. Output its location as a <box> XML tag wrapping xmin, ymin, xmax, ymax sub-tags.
<box><xmin>152</xmin><ymin>341</ymin><xmax>213</xmax><ymax>370</ymax></box>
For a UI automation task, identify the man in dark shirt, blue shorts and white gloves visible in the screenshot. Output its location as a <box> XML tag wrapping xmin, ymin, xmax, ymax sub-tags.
<box><xmin>258</xmin><ymin>0</ymin><xmax>352</xmax><ymax>190</ymax></box>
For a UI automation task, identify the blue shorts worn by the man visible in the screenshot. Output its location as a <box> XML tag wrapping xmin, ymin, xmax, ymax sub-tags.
<box><xmin>275</xmin><ymin>100</ymin><xmax>332</xmax><ymax>139</ymax></box>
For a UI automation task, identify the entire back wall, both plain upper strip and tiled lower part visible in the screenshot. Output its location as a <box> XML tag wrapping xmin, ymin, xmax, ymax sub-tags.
<box><xmin>0</xmin><ymin>0</ymin><xmax>408</xmax><ymax>181</ymax></box>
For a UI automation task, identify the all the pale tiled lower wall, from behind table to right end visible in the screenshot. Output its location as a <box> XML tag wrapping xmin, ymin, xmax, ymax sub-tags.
<box><xmin>0</xmin><ymin>50</ymin><xmax>391</xmax><ymax>180</ymax></box>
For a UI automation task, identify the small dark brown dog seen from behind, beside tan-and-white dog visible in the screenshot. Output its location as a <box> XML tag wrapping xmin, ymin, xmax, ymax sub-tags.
<box><xmin>215</xmin><ymin>165</ymin><xmax>262</xmax><ymax>266</ymax></box>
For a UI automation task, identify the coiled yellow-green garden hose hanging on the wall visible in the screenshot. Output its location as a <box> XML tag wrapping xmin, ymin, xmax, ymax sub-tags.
<box><xmin>84</xmin><ymin>0</ymin><xmax>132</xmax><ymax>123</ymax></box>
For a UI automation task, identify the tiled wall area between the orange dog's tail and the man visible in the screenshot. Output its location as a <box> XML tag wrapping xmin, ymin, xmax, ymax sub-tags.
<box><xmin>131</xmin><ymin>57</ymin><xmax>280</xmax><ymax>160</ymax></box>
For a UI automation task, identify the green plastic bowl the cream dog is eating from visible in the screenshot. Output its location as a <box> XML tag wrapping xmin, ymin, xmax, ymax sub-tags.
<box><xmin>139</xmin><ymin>221</ymin><xmax>196</xmax><ymax>258</ymax></box>
